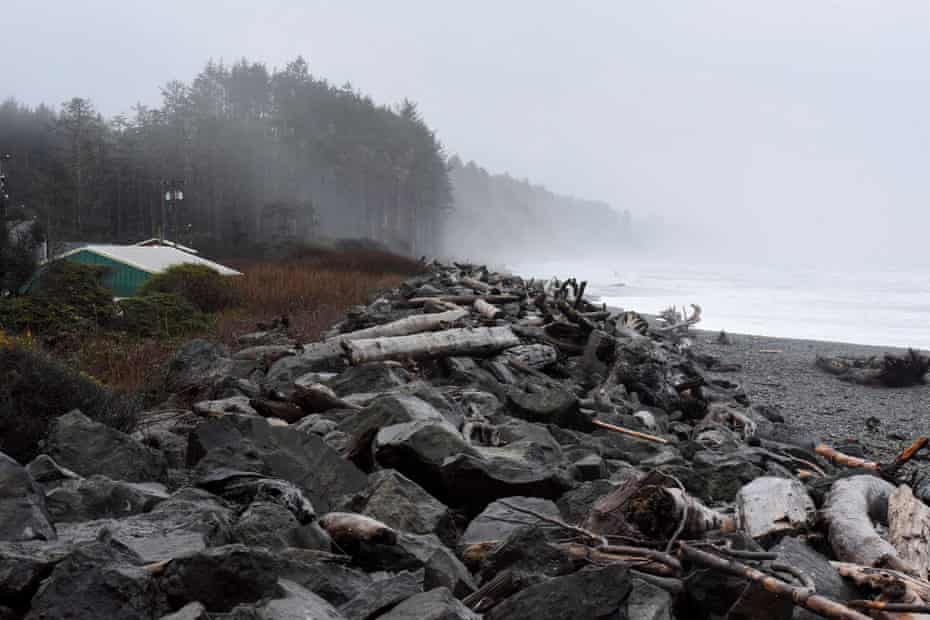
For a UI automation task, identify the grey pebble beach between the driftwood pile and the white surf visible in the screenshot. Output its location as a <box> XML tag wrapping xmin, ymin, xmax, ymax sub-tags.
<box><xmin>692</xmin><ymin>329</ymin><xmax>930</xmax><ymax>460</ymax></box>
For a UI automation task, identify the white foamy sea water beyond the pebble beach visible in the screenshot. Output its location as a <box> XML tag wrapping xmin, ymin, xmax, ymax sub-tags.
<box><xmin>511</xmin><ymin>259</ymin><xmax>930</xmax><ymax>350</ymax></box>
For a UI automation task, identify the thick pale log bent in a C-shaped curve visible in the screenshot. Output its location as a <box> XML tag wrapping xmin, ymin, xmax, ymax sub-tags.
<box><xmin>823</xmin><ymin>475</ymin><xmax>916</xmax><ymax>574</ymax></box>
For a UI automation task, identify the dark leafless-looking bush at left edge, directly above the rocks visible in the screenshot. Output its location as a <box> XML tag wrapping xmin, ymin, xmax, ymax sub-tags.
<box><xmin>0</xmin><ymin>346</ymin><xmax>139</xmax><ymax>463</ymax></box>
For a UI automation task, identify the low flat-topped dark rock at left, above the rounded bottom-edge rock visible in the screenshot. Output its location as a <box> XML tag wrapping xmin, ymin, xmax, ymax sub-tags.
<box><xmin>45</xmin><ymin>476</ymin><xmax>169</xmax><ymax>523</ymax></box>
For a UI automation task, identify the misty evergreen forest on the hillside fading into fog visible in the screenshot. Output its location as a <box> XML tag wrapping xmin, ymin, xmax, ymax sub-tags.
<box><xmin>0</xmin><ymin>57</ymin><xmax>630</xmax><ymax>274</ymax></box>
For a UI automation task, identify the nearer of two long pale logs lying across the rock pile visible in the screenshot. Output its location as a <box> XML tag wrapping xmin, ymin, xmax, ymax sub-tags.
<box><xmin>342</xmin><ymin>327</ymin><xmax>520</xmax><ymax>365</ymax></box>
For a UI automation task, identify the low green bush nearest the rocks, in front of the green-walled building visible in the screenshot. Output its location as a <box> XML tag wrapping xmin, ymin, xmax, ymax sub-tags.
<box><xmin>116</xmin><ymin>293</ymin><xmax>209</xmax><ymax>338</ymax></box>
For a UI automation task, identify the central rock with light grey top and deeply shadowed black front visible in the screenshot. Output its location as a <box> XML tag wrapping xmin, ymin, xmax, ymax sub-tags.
<box><xmin>374</xmin><ymin>421</ymin><xmax>477</xmax><ymax>494</ymax></box>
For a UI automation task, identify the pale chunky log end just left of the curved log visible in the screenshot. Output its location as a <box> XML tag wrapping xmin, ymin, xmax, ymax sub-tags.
<box><xmin>736</xmin><ymin>476</ymin><xmax>817</xmax><ymax>543</ymax></box>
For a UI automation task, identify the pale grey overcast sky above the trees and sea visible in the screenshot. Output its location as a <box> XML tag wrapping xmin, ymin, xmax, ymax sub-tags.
<box><xmin>0</xmin><ymin>0</ymin><xmax>930</xmax><ymax>267</ymax></box>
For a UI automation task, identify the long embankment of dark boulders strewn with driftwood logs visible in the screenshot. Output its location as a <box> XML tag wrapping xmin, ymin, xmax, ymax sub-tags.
<box><xmin>0</xmin><ymin>265</ymin><xmax>930</xmax><ymax>620</ymax></box>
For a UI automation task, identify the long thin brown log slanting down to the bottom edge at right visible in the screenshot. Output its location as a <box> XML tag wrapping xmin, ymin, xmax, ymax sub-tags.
<box><xmin>679</xmin><ymin>543</ymin><xmax>869</xmax><ymax>620</ymax></box>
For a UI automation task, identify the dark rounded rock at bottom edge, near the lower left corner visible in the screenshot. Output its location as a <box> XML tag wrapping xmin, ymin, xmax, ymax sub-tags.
<box><xmin>26</xmin><ymin>542</ymin><xmax>170</xmax><ymax>620</ymax></box>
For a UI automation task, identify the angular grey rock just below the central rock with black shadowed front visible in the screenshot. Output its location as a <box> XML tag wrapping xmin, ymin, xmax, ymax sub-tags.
<box><xmin>343</xmin><ymin>469</ymin><xmax>455</xmax><ymax>543</ymax></box>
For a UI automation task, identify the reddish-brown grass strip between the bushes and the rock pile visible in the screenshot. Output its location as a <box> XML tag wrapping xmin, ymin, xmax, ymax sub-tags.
<box><xmin>73</xmin><ymin>248</ymin><xmax>423</xmax><ymax>393</ymax></box>
